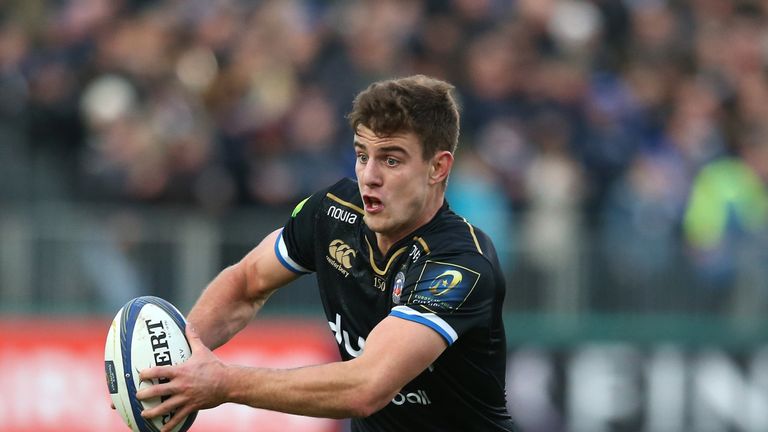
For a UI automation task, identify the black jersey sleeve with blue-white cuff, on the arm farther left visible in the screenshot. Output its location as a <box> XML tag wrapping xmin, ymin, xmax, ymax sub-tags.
<box><xmin>275</xmin><ymin>192</ymin><xmax>325</xmax><ymax>274</ymax></box>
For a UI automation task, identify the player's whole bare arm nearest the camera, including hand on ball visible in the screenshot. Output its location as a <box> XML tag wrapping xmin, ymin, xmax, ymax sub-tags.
<box><xmin>137</xmin><ymin>316</ymin><xmax>448</xmax><ymax>432</ymax></box>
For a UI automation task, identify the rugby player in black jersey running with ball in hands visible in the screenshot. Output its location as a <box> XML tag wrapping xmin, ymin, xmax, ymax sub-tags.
<box><xmin>138</xmin><ymin>75</ymin><xmax>516</xmax><ymax>431</ymax></box>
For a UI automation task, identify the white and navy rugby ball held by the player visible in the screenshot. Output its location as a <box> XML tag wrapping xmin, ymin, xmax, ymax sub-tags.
<box><xmin>104</xmin><ymin>296</ymin><xmax>197</xmax><ymax>432</ymax></box>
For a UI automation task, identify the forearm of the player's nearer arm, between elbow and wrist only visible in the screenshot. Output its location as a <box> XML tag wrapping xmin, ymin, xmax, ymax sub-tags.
<box><xmin>226</xmin><ymin>360</ymin><xmax>396</xmax><ymax>418</ymax></box>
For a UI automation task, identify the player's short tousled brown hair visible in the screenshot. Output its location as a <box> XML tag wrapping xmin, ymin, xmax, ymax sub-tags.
<box><xmin>347</xmin><ymin>75</ymin><xmax>459</xmax><ymax>159</ymax></box>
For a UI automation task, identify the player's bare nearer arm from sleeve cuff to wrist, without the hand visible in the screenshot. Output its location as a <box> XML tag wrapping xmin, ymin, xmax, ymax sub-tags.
<box><xmin>223</xmin><ymin>317</ymin><xmax>447</xmax><ymax>418</ymax></box>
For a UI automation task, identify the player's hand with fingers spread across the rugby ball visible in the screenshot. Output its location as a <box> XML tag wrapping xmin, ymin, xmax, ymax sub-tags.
<box><xmin>136</xmin><ymin>326</ymin><xmax>227</xmax><ymax>432</ymax></box>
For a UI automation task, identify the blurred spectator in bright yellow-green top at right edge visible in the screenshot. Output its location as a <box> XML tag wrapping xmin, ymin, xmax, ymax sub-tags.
<box><xmin>685</xmin><ymin>131</ymin><xmax>768</xmax><ymax>316</ymax></box>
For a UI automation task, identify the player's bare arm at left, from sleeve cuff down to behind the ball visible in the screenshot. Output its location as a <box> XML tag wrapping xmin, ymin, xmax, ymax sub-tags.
<box><xmin>187</xmin><ymin>229</ymin><xmax>299</xmax><ymax>349</ymax></box>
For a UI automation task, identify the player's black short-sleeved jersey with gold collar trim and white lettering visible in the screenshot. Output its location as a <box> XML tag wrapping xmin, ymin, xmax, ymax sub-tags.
<box><xmin>275</xmin><ymin>179</ymin><xmax>515</xmax><ymax>431</ymax></box>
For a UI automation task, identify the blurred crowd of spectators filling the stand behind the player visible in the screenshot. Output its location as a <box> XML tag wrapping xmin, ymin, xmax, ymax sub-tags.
<box><xmin>0</xmin><ymin>0</ymin><xmax>768</xmax><ymax>310</ymax></box>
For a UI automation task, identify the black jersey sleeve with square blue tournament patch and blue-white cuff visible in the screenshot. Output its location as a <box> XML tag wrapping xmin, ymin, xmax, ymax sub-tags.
<box><xmin>390</xmin><ymin>255</ymin><xmax>496</xmax><ymax>345</ymax></box>
